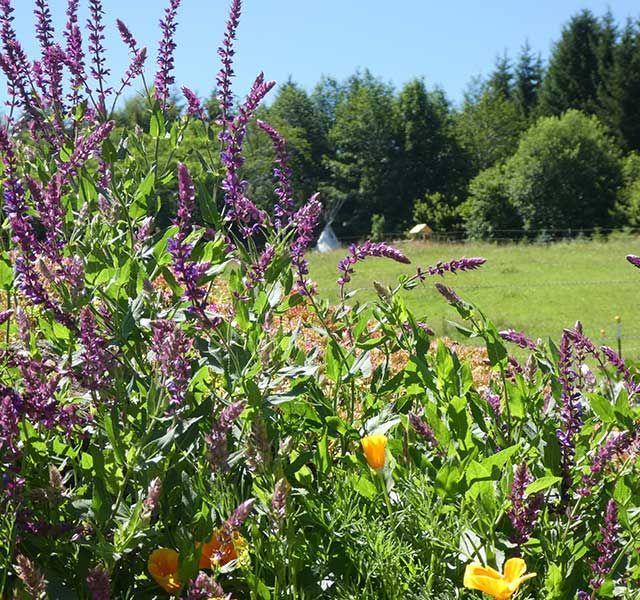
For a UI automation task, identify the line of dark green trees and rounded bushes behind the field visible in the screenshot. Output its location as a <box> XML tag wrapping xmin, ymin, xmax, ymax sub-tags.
<box><xmin>112</xmin><ymin>10</ymin><xmax>640</xmax><ymax>239</ymax></box>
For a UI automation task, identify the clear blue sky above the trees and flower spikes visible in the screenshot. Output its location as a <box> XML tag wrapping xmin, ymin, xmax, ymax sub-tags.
<box><xmin>0</xmin><ymin>0</ymin><xmax>640</xmax><ymax>108</ymax></box>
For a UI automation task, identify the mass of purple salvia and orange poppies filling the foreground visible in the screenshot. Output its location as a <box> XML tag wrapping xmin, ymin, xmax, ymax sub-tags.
<box><xmin>0</xmin><ymin>0</ymin><xmax>640</xmax><ymax>600</ymax></box>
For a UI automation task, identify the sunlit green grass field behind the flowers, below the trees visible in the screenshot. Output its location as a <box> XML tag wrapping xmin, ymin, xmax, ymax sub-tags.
<box><xmin>309</xmin><ymin>236</ymin><xmax>640</xmax><ymax>358</ymax></box>
